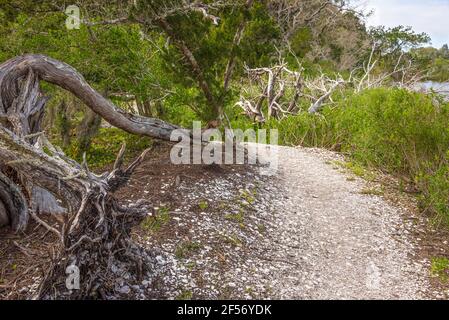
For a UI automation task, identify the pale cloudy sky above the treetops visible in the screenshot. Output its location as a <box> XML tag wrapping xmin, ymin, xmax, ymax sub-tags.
<box><xmin>359</xmin><ymin>0</ymin><xmax>449</xmax><ymax>48</ymax></box>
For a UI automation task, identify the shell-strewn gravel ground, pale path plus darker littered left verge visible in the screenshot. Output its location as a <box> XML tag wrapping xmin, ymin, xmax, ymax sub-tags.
<box><xmin>128</xmin><ymin>147</ymin><xmax>444</xmax><ymax>299</ymax></box>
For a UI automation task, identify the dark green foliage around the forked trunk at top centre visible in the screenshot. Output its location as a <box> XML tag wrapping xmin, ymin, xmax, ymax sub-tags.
<box><xmin>160</xmin><ymin>2</ymin><xmax>280</xmax><ymax>121</ymax></box>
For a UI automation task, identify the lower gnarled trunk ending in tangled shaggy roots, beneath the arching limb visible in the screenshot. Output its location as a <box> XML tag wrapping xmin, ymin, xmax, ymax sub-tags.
<box><xmin>0</xmin><ymin>127</ymin><xmax>148</xmax><ymax>299</ymax></box>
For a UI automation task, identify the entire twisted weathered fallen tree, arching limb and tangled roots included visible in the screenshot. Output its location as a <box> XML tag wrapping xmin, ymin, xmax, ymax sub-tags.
<box><xmin>0</xmin><ymin>55</ymin><xmax>184</xmax><ymax>298</ymax></box>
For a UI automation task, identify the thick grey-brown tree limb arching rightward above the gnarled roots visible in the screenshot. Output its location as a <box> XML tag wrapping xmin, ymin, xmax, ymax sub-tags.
<box><xmin>0</xmin><ymin>54</ymin><xmax>179</xmax><ymax>140</ymax></box>
